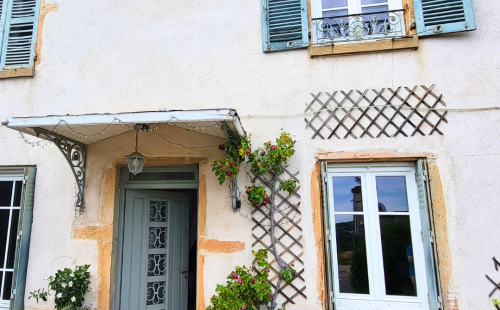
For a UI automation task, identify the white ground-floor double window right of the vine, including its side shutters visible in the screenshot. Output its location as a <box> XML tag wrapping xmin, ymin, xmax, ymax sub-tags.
<box><xmin>322</xmin><ymin>161</ymin><xmax>441</xmax><ymax>310</ymax></box>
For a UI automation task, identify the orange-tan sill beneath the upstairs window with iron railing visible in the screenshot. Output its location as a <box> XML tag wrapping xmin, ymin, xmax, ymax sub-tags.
<box><xmin>309</xmin><ymin>36</ymin><xmax>418</xmax><ymax>57</ymax></box>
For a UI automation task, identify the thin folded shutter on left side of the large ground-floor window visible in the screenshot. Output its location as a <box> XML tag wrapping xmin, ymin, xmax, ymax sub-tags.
<box><xmin>321</xmin><ymin>163</ymin><xmax>336</xmax><ymax>310</ymax></box>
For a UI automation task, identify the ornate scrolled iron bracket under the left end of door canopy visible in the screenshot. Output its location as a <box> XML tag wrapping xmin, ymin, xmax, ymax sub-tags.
<box><xmin>33</xmin><ymin>127</ymin><xmax>87</xmax><ymax>213</ymax></box>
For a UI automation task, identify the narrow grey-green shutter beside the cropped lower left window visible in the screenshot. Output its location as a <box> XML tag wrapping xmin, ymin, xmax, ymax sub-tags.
<box><xmin>10</xmin><ymin>167</ymin><xmax>36</xmax><ymax>310</ymax></box>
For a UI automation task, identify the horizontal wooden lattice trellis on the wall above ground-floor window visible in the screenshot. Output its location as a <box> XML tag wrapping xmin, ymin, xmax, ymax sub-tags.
<box><xmin>305</xmin><ymin>85</ymin><xmax>448</xmax><ymax>139</ymax></box>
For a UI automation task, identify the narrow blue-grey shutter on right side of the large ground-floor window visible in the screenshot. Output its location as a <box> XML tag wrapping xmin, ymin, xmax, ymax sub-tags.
<box><xmin>416</xmin><ymin>159</ymin><xmax>442</xmax><ymax>310</ymax></box>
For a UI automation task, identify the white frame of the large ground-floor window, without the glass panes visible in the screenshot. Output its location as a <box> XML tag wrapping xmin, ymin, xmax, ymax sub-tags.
<box><xmin>327</xmin><ymin>163</ymin><xmax>429</xmax><ymax>310</ymax></box>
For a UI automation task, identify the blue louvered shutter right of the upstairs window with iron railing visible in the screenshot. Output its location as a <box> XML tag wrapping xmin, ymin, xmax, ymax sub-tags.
<box><xmin>413</xmin><ymin>0</ymin><xmax>477</xmax><ymax>36</ymax></box>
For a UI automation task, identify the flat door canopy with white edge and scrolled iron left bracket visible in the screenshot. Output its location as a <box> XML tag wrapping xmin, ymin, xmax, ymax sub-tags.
<box><xmin>2</xmin><ymin>109</ymin><xmax>245</xmax><ymax>211</ymax></box>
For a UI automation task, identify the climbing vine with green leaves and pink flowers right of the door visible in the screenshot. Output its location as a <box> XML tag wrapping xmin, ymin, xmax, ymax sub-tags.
<box><xmin>207</xmin><ymin>132</ymin><xmax>297</xmax><ymax>310</ymax></box>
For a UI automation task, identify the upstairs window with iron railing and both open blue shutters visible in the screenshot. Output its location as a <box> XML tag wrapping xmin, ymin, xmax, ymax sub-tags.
<box><xmin>261</xmin><ymin>0</ymin><xmax>476</xmax><ymax>52</ymax></box>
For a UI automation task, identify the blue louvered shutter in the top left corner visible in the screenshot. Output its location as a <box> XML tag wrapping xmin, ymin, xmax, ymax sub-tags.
<box><xmin>0</xmin><ymin>0</ymin><xmax>40</xmax><ymax>69</ymax></box>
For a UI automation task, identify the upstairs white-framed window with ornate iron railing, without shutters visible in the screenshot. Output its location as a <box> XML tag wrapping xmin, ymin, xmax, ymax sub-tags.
<box><xmin>311</xmin><ymin>0</ymin><xmax>405</xmax><ymax>43</ymax></box>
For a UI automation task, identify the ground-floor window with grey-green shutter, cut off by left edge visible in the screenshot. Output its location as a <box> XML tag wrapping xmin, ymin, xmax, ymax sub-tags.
<box><xmin>0</xmin><ymin>167</ymin><xmax>36</xmax><ymax>310</ymax></box>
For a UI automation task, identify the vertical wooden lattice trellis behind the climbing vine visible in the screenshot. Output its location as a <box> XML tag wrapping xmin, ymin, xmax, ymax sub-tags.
<box><xmin>252</xmin><ymin>169</ymin><xmax>307</xmax><ymax>306</ymax></box>
